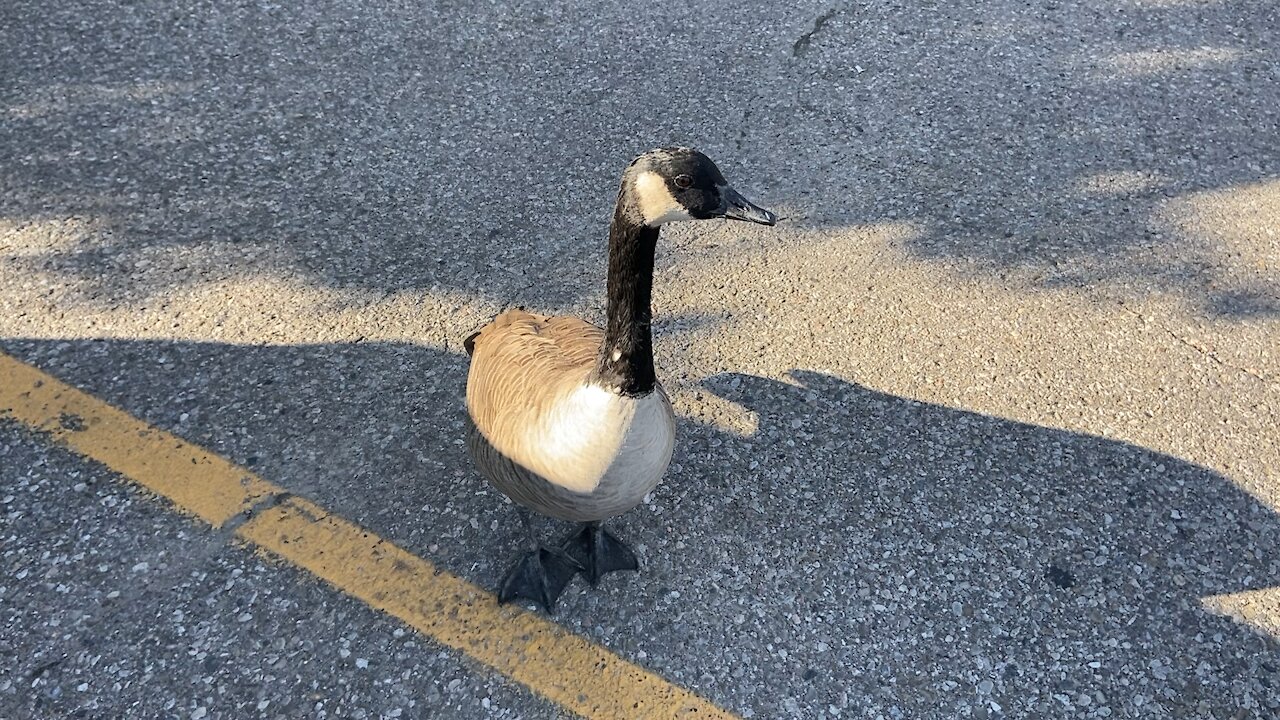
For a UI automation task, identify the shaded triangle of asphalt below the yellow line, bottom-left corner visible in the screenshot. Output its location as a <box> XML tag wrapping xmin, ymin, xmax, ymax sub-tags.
<box><xmin>0</xmin><ymin>423</ymin><xmax>558</xmax><ymax>720</ymax></box>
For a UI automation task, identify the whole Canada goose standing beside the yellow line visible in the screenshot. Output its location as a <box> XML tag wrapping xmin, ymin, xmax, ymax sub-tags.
<box><xmin>463</xmin><ymin>147</ymin><xmax>777</xmax><ymax>612</ymax></box>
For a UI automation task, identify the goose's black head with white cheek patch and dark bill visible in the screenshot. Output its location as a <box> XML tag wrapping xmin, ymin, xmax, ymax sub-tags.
<box><xmin>622</xmin><ymin>147</ymin><xmax>778</xmax><ymax>228</ymax></box>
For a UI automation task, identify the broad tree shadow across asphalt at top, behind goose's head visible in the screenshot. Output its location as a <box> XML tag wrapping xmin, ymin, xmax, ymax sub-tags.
<box><xmin>0</xmin><ymin>0</ymin><xmax>1280</xmax><ymax>318</ymax></box>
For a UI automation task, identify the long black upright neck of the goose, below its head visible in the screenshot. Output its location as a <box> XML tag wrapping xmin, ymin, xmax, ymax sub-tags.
<box><xmin>595</xmin><ymin>197</ymin><xmax>658</xmax><ymax>397</ymax></box>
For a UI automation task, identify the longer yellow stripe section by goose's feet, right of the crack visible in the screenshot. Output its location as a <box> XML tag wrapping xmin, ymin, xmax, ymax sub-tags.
<box><xmin>237</xmin><ymin>498</ymin><xmax>732</xmax><ymax>717</ymax></box>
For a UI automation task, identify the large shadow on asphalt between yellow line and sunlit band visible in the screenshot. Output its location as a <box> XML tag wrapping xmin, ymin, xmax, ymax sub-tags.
<box><xmin>0</xmin><ymin>340</ymin><xmax>1280</xmax><ymax>717</ymax></box>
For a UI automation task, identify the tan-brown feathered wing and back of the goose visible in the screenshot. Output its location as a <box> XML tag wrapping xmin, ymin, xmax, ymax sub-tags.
<box><xmin>467</xmin><ymin>304</ymin><xmax>604</xmax><ymax>438</ymax></box>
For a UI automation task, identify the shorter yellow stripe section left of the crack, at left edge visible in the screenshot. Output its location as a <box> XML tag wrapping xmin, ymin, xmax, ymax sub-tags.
<box><xmin>0</xmin><ymin>352</ymin><xmax>280</xmax><ymax>520</ymax></box>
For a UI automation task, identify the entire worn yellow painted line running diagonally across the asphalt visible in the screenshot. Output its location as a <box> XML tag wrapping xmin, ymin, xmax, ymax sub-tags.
<box><xmin>0</xmin><ymin>352</ymin><xmax>735</xmax><ymax>719</ymax></box>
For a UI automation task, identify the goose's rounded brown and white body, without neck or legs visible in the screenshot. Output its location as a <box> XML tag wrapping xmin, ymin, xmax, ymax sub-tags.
<box><xmin>467</xmin><ymin>304</ymin><xmax>676</xmax><ymax>521</ymax></box>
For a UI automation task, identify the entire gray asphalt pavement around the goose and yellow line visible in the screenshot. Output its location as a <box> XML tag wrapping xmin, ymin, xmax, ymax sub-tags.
<box><xmin>0</xmin><ymin>0</ymin><xmax>1280</xmax><ymax>719</ymax></box>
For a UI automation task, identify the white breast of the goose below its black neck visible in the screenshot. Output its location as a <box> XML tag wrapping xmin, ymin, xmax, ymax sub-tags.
<box><xmin>520</xmin><ymin>384</ymin><xmax>676</xmax><ymax>497</ymax></box>
